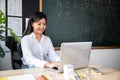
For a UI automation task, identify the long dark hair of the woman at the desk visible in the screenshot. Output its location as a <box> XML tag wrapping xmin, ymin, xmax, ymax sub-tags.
<box><xmin>22</xmin><ymin>11</ymin><xmax>47</xmax><ymax>37</ymax></box>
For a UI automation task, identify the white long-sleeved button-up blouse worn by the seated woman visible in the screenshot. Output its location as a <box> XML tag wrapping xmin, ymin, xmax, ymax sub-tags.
<box><xmin>21</xmin><ymin>32</ymin><xmax>59</xmax><ymax>68</ymax></box>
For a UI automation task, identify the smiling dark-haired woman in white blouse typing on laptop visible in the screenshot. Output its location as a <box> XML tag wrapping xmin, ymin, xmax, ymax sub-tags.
<box><xmin>21</xmin><ymin>12</ymin><xmax>59</xmax><ymax>68</ymax></box>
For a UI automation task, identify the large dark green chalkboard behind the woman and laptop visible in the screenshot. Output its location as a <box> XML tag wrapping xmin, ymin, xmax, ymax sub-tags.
<box><xmin>43</xmin><ymin>0</ymin><xmax>120</xmax><ymax>47</ymax></box>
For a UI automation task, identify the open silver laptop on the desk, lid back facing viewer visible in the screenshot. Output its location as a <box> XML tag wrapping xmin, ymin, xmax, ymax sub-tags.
<box><xmin>53</xmin><ymin>42</ymin><xmax>92</xmax><ymax>72</ymax></box>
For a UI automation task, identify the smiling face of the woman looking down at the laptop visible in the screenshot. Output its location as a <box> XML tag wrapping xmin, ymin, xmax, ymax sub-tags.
<box><xmin>32</xmin><ymin>18</ymin><xmax>46</xmax><ymax>34</ymax></box>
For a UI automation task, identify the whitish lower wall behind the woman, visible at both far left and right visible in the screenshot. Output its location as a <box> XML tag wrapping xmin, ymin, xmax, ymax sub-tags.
<box><xmin>0</xmin><ymin>49</ymin><xmax>120</xmax><ymax>70</ymax></box>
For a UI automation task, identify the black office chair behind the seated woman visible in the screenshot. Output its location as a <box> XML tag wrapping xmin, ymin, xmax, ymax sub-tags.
<box><xmin>6</xmin><ymin>36</ymin><xmax>23</xmax><ymax>69</ymax></box>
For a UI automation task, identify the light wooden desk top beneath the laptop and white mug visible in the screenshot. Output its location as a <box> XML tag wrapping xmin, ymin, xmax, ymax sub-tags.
<box><xmin>0</xmin><ymin>65</ymin><xmax>120</xmax><ymax>80</ymax></box>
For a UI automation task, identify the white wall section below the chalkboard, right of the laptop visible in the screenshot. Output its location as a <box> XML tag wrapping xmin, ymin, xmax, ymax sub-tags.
<box><xmin>90</xmin><ymin>49</ymin><xmax>120</xmax><ymax>70</ymax></box>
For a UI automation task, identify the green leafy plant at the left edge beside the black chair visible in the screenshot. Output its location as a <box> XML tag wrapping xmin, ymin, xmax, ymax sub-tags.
<box><xmin>0</xmin><ymin>10</ymin><xmax>20</xmax><ymax>57</ymax></box>
